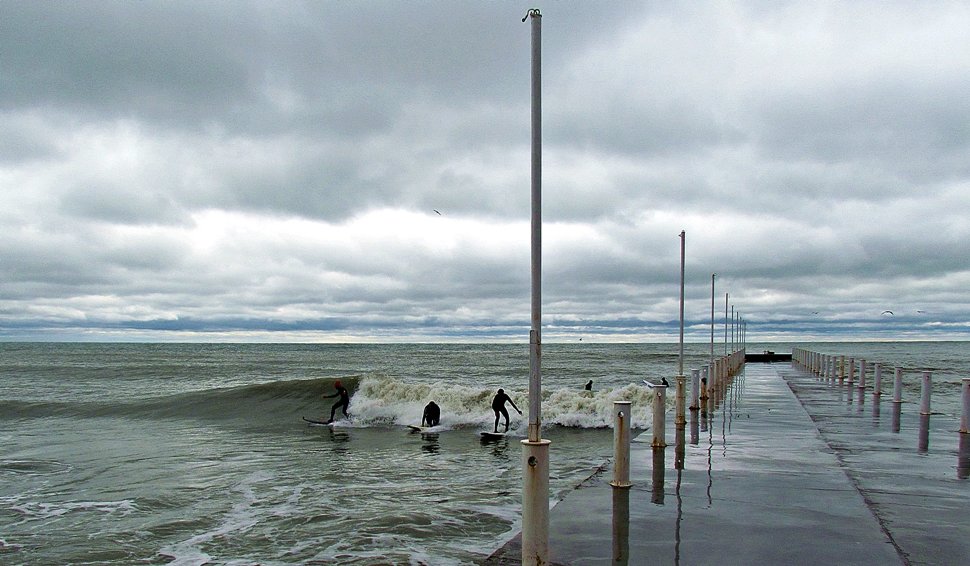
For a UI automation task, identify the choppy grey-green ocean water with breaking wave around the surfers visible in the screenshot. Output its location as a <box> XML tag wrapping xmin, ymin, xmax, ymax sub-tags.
<box><xmin>0</xmin><ymin>342</ymin><xmax>970</xmax><ymax>565</ymax></box>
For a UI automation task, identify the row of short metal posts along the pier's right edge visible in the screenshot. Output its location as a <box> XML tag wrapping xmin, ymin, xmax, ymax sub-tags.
<box><xmin>792</xmin><ymin>348</ymin><xmax>970</xmax><ymax>478</ymax></box>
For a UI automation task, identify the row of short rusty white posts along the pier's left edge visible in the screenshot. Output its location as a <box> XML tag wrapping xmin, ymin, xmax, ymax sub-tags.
<box><xmin>610</xmin><ymin>349</ymin><xmax>745</xmax><ymax>488</ymax></box>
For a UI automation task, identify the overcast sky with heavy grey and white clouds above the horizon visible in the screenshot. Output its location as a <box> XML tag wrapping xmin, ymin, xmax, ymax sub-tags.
<box><xmin>0</xmin><ymin>0</ymin><xmax>970</xmax><ymax>343</ymax></box>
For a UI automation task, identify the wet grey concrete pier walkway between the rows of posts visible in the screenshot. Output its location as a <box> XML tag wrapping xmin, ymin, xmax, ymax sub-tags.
<box><xmin>485</xmin><ymin>363</ymin><xmax>970</xmax><ymax>566</ymax></box>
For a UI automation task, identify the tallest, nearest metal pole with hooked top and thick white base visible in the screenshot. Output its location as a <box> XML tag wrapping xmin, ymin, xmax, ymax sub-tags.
<box><xmin>522</xmin><ymin>9</ymin><xmax>550</xmax><ymax>566</ymax></box>
